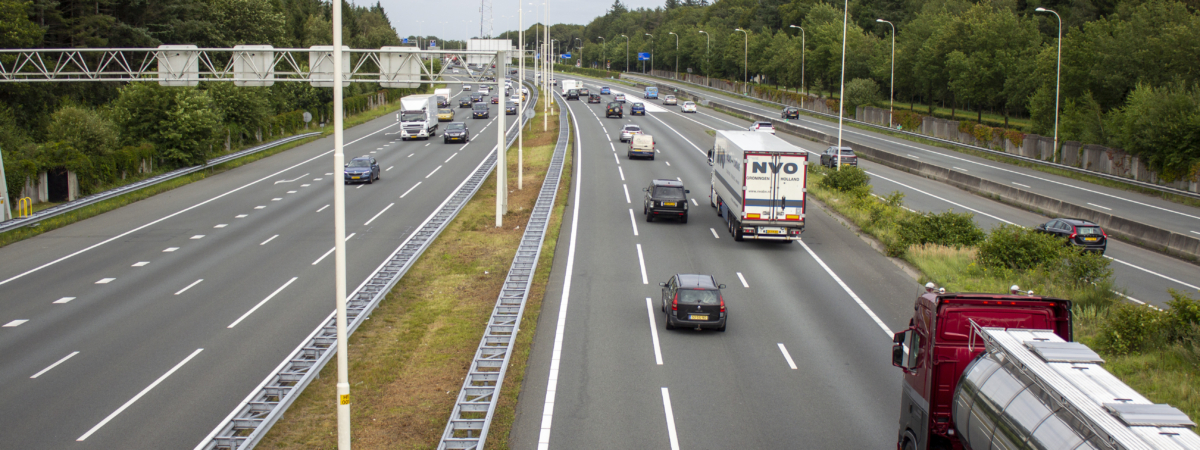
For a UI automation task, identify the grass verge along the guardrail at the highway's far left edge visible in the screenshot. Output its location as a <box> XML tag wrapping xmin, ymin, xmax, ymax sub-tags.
<box><xmin>0</xmin><ymin>102</ymin><xmax>400</xmax><ymax>247</ymax></box>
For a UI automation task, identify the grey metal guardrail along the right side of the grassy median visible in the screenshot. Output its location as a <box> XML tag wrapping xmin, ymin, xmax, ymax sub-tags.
<box><xmin>438</xmin><ymin>92</ymin><xmax>570</xmax><ymax>450</ymax></box>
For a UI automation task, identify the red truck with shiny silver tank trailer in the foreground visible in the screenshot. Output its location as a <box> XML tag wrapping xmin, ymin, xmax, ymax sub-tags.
<box><xmin>892</xmin><ymin>283</ymin><xmax>1200</xmax><ymax>450</ymax></box>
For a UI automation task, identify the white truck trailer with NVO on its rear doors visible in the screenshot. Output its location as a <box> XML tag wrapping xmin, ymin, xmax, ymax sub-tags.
<box><xmin>709</xmin><ymin>130</ymin><xmax>809</xmax><ymax>241</ymax></box>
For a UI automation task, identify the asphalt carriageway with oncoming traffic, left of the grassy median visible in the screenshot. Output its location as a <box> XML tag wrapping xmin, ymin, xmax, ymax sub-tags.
<box><xmin>0</xmin><ymin>82</ymin><xmax>525</xmax><ymax>449</ymax></box>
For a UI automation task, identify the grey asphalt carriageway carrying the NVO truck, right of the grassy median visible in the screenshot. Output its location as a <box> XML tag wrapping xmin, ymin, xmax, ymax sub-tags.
<box><xmin>512</xmin><ymin>73</ymin><xmax>1200</xmax><ymax>449</ymax></box>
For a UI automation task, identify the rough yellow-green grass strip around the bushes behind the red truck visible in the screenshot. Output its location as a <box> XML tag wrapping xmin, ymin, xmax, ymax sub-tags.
<box><xmin>808</xmin><ymin>167</ymin><xmax>1200</xmax><ymax>421</ymax></box>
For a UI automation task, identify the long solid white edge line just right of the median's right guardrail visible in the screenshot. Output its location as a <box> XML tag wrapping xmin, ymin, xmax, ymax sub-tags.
<box><xmin>538</xmin><ymin>106</ymin><xmax>583</xmax><ymax>450</ymax></box>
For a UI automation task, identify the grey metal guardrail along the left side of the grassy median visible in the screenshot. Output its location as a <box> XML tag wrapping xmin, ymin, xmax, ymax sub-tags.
<box><xmin>196</xmin><ymin>82</ymin><xmax>538</xmax><ymax>450</ymax></box>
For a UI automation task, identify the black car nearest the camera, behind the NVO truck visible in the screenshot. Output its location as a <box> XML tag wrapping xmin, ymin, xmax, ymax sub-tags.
<box><xmin>659</xmin><ymin>274</ymin><xmax>730</xmax><ymax>331</ymax></box>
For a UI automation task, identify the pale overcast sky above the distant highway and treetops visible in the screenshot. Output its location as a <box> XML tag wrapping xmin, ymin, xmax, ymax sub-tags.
<box><xmin>369</xmin><ymin>0</ymin><xmax>664</xmax><ymax>40</ymax></box>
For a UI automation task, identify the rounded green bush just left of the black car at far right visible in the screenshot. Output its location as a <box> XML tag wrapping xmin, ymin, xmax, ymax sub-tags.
<box><xmin>978</xmin><ymin>224</ymin><xmax>1066</xmax><ymax>270</ymax></box>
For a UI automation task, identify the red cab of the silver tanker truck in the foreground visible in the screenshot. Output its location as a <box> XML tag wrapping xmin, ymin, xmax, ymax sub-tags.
<box><xmin>892</xmin><ymin>283</ymin><xmax>1072</xmax><ymax>450</ymax></box>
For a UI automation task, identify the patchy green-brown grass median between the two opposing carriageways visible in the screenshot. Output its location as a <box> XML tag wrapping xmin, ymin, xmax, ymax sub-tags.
<box><xmin>259</xmin><ymin>97</ymin><xmax>570</xmax><ymax>449</ymax></box>
